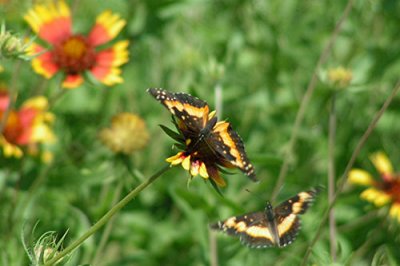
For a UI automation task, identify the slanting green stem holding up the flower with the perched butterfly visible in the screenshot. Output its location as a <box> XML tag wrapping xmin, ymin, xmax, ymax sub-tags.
<box><xmin>45</xmin><ymin>165</ymin><xmax>170</xmax><ymax>265</ymax></box>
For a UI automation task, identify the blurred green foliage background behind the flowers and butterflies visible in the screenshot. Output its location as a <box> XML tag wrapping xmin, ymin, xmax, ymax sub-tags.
<box><xmin>0</xmin><ymin>0</ymin><xmax>400</xmax><ymax>266</ymax></box>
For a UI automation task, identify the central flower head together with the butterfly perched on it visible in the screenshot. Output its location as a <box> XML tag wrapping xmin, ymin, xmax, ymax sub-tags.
<box><xmin>148</xmin><ymin>88</ymin><xmax>257</xmax><ymax>188</ymax></box>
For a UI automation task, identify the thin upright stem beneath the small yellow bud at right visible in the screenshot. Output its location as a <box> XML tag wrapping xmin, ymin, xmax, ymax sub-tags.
<box><xmin>328</xmin><ymin>92</ymin><xmax>336</xmax><ymax>262</ymax></box>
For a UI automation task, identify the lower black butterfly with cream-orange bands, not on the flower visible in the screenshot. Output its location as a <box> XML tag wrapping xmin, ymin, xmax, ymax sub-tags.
<box><xmin>211</xmin><ymin>187</ymin><xmax>321</xmax><ymax>248</ymax></box>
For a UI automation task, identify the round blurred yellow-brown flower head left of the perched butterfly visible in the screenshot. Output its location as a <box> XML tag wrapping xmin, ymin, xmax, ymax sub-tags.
<box><xmin>99</xmin><ymin>113</ymin><xmax>149</xmax><ymax>155</ymax></box>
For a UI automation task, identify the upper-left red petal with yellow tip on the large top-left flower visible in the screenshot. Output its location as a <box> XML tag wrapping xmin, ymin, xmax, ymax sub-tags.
<box><xmin>24</xmin><ymin>1</ymin><xmax>71</xmax><ymax>44</ymax></box>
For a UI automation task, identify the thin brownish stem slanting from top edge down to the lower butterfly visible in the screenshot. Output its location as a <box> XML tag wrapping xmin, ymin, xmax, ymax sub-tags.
<box><xmin>271</xmin><ymin>0</ymin><xmax>354</xmax><ymax>203</ymax></box>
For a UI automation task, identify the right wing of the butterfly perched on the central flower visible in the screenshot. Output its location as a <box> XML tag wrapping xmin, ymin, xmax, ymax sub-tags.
<box><xmin>208</xmin><ymin>121</ymin><xmax>257</xmax><ymax>181</ymax></box>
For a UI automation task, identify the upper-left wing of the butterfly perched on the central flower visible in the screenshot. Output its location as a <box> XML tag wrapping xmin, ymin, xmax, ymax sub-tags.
<box><xmin>147</xmin><ymin>88</ymin><xmax>209</xmax><ymax>137</ymax></box>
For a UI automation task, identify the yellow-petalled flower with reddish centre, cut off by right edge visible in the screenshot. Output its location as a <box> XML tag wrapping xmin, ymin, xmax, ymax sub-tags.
<box><xmin>349</xmin><ymin>152</ymin><xmax>400</xmax><ymax>223</ymax></box>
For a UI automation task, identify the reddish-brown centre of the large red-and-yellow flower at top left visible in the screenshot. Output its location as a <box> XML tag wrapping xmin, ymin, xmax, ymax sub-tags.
<box><xmin>53</xmin><ymin>35</ymin><xmax>96</xmax><ymax>75</ymax></box>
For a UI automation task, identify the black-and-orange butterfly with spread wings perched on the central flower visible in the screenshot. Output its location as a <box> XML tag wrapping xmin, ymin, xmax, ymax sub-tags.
<box><xmin>148</xmin><ymin>88</ymin><xmax>257</xmax><ymax>181</ymax></box>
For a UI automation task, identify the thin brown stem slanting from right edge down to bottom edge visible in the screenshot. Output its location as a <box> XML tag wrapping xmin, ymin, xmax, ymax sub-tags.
<box><xmin>301</xmin><ymin>80</ymin><xmax>400</xmax><ymax>265</ymax></box>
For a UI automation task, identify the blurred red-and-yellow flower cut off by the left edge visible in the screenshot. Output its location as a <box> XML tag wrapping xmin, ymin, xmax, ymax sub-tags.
<box><xmin>0</xmin><ymin>91</ymin><xmax>55</xmax><ymax>159</ymax></box>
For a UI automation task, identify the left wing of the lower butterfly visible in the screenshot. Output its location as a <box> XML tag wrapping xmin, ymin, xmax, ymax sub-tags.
<box><xmin>211</xmin><ymin>212</ymin><xmax>275</xmax><ymax>248</ymax></box>
